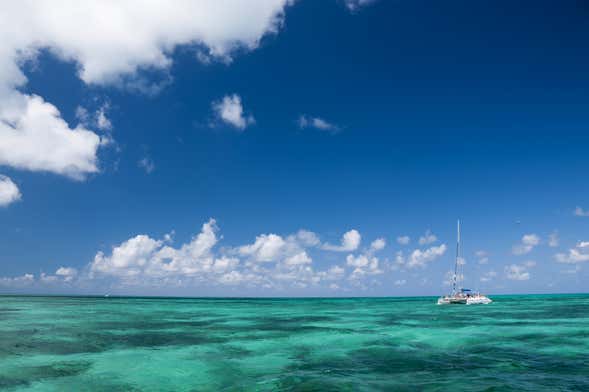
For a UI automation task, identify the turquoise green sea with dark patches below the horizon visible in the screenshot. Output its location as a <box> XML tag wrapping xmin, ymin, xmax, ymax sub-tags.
<box><xmin>0</xmin><ymin>295</ymin><xmax>589</xmax><ymax>391</ymax></box>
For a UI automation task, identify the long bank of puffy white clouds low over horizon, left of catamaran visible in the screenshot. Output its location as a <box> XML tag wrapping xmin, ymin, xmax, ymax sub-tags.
<box><xmin>0</xmin><ymin>219</ymin><xmax>385</xmax><ymax>292</ymax></box>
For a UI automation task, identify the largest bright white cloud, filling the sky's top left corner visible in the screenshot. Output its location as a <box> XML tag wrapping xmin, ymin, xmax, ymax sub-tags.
<box><xmin>0</xmin><ymin>0</ymin><xmax>289</xmax><ymax>84</ymax></box>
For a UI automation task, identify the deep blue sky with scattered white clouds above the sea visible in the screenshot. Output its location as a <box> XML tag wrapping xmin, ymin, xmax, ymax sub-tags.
<box><xmin>0</xmin><ymin>0</ymin><xmax>589</xmax><ymax>296</ymax></box>
